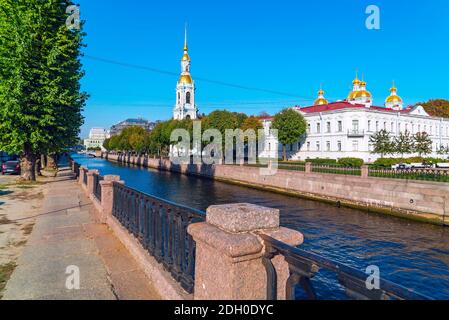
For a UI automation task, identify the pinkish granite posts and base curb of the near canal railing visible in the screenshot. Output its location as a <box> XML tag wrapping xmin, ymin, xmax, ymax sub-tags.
<box><xmin>74</xmin><ymin>162</ymin><xmax>303</xmax><ymax>300</ymax></box>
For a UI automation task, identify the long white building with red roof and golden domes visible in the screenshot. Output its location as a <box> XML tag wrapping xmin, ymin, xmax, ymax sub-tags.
<box><xmin>259</xmin><ymin>78</ymin><xmax>449</xmax><ymax>162</ymax></box>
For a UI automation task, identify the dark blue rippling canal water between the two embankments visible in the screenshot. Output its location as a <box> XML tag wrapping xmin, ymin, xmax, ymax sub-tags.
<box><xmin>74</xmin><ymin>155</ymin><xmax>449</xmax><ymax>299</ymax></box>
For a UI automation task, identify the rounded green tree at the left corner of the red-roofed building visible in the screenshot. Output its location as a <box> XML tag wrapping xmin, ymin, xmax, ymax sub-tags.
<box><xmin>271</xmin><ymin>108</ymin><xmax>307</xmax><ymax>161</ymax></box>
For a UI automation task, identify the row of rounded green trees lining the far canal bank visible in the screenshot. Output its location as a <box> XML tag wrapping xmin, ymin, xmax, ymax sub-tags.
<box><xmin>103</xmin><ymin>109</ymin><xmax>307</xmax><ymax>159</ymax></box>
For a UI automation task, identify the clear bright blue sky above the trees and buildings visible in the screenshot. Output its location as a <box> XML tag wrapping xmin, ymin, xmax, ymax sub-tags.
<box><xmin>78</xmin><ymin>0</ymin><xmax>449</xmax><ymax>137</ymax></box>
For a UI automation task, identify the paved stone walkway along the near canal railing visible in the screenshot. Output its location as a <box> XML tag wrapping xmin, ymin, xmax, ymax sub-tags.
<box><xmin>3</xmin><ymin>171</ymin><xmax>159</xmax><ymax>300</ymax></box>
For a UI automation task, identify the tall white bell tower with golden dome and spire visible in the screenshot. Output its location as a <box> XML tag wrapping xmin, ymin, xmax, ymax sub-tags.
<box><xmin>173</xmin><ymin>31</ymin><xmax>198</xmax><ymax>120</ymax></box>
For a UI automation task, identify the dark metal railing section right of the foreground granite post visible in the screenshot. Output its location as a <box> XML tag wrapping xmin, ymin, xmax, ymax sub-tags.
<box><xmin>260</xmin><ymin>234</ymin><xmax>430</xmax><ymax>300</ymax></box>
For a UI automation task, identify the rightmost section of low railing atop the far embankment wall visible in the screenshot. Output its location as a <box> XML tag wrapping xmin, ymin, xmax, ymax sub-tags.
<box><xmin>368</xmin><ymin>168</ymin><xmax>449</xmax><ymax>182</ymax></box>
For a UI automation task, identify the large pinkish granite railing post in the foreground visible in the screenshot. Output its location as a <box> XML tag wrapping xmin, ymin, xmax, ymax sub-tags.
<box><xmin>188</xmin><ymin>204</ymin><xmax>303</xmax><ymax>300</ymax></box>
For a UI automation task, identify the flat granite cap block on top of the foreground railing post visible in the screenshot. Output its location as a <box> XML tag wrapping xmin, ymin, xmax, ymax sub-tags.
<box><xmin>206</xmin><ymin>203</ymin><xmax>279</xmax><ymax>233</ymax></box>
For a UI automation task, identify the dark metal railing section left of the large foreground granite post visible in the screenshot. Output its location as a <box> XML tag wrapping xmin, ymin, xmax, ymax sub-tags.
<box><xmin>112</xmin><ymin>182</ymin><xmax>206</xmax><ymax>293</ymax></box>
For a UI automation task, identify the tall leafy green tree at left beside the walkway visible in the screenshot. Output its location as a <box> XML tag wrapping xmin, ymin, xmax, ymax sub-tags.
<box><xmin>0</xmin><ymin>0</ymin><xmax>87</xmax><ymax>180</ymax></box>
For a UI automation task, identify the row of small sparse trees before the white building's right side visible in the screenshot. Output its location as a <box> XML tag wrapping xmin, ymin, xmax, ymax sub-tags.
<box><xmin>370</xmin><ymin>130</ymin><xmax>440</xmax><ymax>158</ymax></box>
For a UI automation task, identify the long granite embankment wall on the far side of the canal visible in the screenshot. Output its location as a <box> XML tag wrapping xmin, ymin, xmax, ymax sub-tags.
<box><xmin>105</xmin><ymin>155</ymin><xmax>449</xmax><ymax>225</ymax></box>
